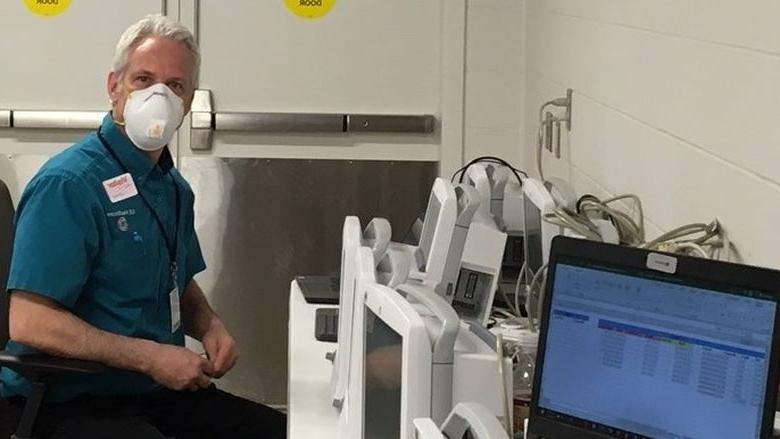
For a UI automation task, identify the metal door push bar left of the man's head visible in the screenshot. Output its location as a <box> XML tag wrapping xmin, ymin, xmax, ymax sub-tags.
<box><xmin>0</xmin><ymin>110</ymin><xmax>106</xmax><ymax>130</ymax></box>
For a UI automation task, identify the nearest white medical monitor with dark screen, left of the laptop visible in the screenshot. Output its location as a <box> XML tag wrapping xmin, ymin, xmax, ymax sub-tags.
<box><xmin>339</xmin><ymin>282</ymin><xmax>512</xmax><ymax>439</ymax></box>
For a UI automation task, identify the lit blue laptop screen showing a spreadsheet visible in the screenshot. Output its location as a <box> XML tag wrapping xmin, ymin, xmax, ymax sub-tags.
<box><xmin>538</xmin><ymin>258</ymin><xmax>776</xmax><ymax>439</ymax></box>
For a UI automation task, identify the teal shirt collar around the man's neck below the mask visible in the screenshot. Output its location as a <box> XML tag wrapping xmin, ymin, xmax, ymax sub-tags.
<box><xmin>100</xmin><ymin>113</ymin><xmax>173</xmax><ymax>181</ymax></box>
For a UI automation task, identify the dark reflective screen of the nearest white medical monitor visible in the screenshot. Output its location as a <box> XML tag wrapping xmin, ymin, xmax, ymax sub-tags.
<box><xmin>363</xmin><ymin>307</ymin><xmax>403</xmax><ymax>439</ymax></box>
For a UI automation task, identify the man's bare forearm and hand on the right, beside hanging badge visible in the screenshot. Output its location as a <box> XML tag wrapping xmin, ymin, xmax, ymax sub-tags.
<box><xmin>181</xmin><ymin>279</ymin><xmax>238</xmax><ymax>378</ymax></box>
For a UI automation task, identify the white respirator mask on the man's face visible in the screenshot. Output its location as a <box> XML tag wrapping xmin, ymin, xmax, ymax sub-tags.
<box><xmin>125</xmin><ymin>84</ymin><xmax>184</xmax><ymax>151</ymax></box>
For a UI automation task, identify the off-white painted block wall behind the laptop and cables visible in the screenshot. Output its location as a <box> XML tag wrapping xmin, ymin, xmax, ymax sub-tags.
<box><xmin>521</xmin><ymin>0</ymin><xmax>780</xmax><ymax>267</ymax></box>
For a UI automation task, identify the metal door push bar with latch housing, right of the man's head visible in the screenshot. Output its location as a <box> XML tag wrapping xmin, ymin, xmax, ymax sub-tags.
<box><xmin>190</xmin><ymin>90</ymin><xmax>436</xmax><ymax>150</ymax></box>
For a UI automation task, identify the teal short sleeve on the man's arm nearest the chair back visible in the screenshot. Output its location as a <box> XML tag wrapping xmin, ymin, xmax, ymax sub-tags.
<box><xmin>8</xmin><ymin>175</ymin><xmax>99</xmax><ymax>308</ymax></box>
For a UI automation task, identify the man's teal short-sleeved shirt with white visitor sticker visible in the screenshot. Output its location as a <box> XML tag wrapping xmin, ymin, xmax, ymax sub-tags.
<box><xmin>0</xmin><ymin>114</ymin><xmax>205</xmax><ymax>401</ymax></box>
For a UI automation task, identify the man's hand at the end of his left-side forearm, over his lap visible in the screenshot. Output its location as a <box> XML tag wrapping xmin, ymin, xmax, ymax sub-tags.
<box><xmin>148</xmin><ymin>344</ymin><xmax>214</xmax><ymax>390</ymax></box>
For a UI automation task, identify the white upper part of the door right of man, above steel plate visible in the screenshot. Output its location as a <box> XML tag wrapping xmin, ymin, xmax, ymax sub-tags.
<box><xmin>182</xmin><ymin>0</ymin><xmax>454</xmax><ymax>162</ymax></box>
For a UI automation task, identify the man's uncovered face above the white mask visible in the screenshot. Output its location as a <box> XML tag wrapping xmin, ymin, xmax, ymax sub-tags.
<box><xmin>108</xmin><ymin>37</ymin><xmax>195</xmax><ymax>122</ymax></box>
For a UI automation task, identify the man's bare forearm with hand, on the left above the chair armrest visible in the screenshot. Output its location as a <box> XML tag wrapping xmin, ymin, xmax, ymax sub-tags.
<box><xmin>8</xmin><ymin>290</ymin><xmax>212</xmax><ymax>390</ymax></box>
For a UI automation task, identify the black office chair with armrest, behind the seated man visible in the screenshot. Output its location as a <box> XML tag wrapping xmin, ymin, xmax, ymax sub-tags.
<box><xmin>0</xmin><ymin>180</ymin><xmax>105</xmax><ymax>439</ymax></box>
